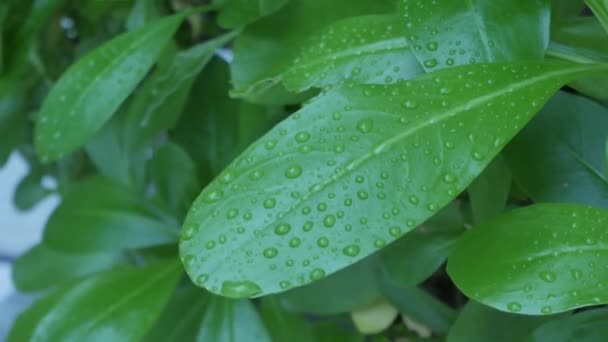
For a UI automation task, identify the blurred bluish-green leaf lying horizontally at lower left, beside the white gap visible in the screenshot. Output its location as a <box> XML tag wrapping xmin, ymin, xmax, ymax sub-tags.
<box><xmin>13</xmin><ymin>244</ymin><xmax>123</xmax><ymax>292</ymax></box>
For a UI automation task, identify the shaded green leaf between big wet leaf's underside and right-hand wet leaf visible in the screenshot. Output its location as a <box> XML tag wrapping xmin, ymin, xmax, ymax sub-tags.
<box><xmin>380</xmin><ymin>202</ymin><xmax>464</xmax><ymax>287</ymax></box>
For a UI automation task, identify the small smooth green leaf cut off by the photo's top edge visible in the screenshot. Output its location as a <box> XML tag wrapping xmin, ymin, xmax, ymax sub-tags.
<box><xmin>217</xmin><ymin>0</ymin><xmax>289</xmax><ymax>28</ymax></box>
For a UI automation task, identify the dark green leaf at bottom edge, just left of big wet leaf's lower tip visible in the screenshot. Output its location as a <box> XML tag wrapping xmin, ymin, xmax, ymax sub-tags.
<box><xmin>142</xmin><ymin>285</ymin><xmax>209</xmax><ymax>342</ymax></box>
